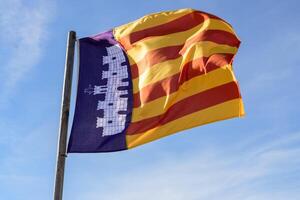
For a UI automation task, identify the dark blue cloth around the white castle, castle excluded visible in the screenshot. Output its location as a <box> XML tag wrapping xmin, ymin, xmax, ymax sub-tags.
<box><xmin>68</xmin><ymin>32</ymin><xmax>133</xmax><ymax>153</ymax></box>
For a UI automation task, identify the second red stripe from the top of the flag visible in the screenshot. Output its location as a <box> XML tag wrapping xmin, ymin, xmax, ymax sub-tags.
<box><xmin>131</xmin><ymin>30</ymin><xmax>240</xmax><ymax>79</ymax></box>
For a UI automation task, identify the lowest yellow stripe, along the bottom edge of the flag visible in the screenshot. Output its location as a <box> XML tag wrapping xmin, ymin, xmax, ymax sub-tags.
<box><xmin>126</xmin><ymin>99</ymin><xmax>244</xmax><ymax>148</ymax></box>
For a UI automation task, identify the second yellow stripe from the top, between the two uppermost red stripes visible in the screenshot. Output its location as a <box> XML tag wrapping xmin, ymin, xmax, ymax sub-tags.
<box><xmin>127</xmin><ymin>19</ymin><xmax>234</xmax><ymax>65</ymax></box>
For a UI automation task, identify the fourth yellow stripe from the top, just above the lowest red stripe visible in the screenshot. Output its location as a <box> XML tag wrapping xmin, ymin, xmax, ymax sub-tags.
<box><xmin>131</xmin><ymin>65</ymin><xmax>235</xmax><ymax>122</ymax></box>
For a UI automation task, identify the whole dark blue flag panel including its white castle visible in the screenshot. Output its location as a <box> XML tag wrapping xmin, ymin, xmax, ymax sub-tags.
<box><xmin>68</xmin><ymin>32</ymin><xmax>133</xmax><ymax>152</ymax></box>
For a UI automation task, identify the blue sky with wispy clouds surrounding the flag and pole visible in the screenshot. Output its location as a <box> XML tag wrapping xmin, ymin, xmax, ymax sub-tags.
<box><xmin>0</xmin><ymin>0</ymin><xmax>300</xmax><ymax>200</ymax></box>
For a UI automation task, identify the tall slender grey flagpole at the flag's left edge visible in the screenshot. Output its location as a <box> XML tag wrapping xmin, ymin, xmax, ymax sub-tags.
<box><xmin>54</xmin><ymin>31</ymin><xmax>76</xmax><ymax>200</ymax></box>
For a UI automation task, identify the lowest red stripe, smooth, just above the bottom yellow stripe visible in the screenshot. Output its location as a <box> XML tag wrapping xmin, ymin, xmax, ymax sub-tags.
<box><xmin>126</xmin><ymin>82</ymin><xmax>240</xmax><ymax>135</ymax></box>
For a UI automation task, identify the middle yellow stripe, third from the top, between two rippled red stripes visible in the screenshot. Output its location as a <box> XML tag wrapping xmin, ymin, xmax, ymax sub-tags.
<box><xmin>132</xmin><ymin>41</ymin><xmax>237</xmax><ymax>93</ymax></box>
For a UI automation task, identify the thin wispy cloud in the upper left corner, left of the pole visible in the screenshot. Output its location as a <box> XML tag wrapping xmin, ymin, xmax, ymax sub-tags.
<box><xmin>0</xmin><ymin>0</ymin><xmax>54</xmax><ymax>106</ymax></box>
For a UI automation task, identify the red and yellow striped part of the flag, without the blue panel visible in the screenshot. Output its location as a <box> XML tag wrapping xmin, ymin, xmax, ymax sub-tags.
<box><xmin>67</xmin><ymin>9</ymin><xmax>244</xmax><ymax>150</ymax></box>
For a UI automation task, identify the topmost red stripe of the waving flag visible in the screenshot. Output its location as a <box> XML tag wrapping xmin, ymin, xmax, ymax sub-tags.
<box><xmin>119</xmin><ymin>11</ymin><xmax>221</xmax><ymax>50</ymax></box>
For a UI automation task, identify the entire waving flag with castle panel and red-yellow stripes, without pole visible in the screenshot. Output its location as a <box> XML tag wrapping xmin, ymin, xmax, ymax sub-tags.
<box><xmin>68</xmin><ymin>9</ymin><xmax>244</xmax><ymax>152</ymax></box>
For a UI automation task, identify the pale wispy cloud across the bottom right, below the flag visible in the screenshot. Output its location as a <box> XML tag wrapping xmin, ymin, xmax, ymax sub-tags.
<box><xmin>78</xmin><ymin>133</ymin><xmax>300</xmax><ymax>200</ymax></box>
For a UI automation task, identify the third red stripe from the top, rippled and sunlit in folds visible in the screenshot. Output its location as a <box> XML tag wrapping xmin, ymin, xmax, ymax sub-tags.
<box><xmin>133</xmin><ymin>54</ymin><xmax>233</xmax><ymax>108</ymax></box>
